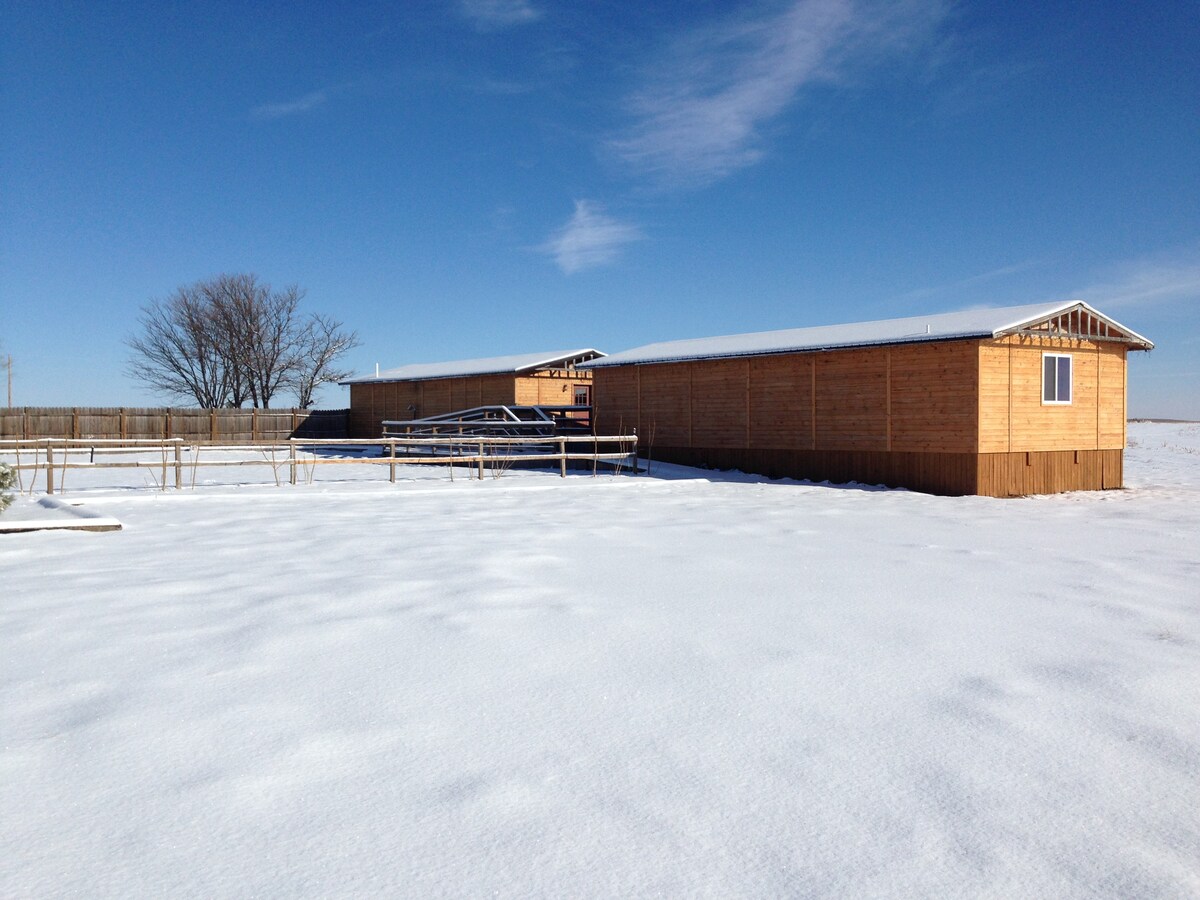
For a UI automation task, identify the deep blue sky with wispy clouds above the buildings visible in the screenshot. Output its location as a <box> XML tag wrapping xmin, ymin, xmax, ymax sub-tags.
<box><xmin>0</xmin><ymin>0</ymin><xmax>1200</xmax><ymax>419</ymax></box>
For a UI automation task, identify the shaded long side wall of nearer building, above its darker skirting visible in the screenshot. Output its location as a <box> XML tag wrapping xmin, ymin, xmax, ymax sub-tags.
<box><xmin>595</xmin><ymin>341</ymin><xmax>978</xmax><ymax>452</ymax></box>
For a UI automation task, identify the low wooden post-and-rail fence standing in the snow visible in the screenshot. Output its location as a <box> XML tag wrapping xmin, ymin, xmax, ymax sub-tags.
<box><xmin>0</xmin><ymin>434</ymin><xmax>637</xmax><ymax>493</ymax></box>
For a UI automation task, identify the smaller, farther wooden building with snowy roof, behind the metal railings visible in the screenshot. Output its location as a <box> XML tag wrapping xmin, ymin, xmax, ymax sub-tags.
<box><xmin>341</xmin><ymin>349</ymin><xmax>604</xmax><ymax>438</ymax></box>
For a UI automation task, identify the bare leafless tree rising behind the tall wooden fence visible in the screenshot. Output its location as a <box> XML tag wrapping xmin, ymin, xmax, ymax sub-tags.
<box><xmin>127</xmin><ymin>275</ymin><xmax>358</xmax><ymax>408</ymax></box>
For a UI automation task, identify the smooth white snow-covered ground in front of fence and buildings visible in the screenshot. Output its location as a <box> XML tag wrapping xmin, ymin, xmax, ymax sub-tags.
<box><xmin>0</xmin><ymin>424</ymin><xmax>1200</xmax><ymax>898</ymax></box>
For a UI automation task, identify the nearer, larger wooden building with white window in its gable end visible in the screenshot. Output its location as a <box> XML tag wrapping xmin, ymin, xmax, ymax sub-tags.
<box><xmin>586</xmin><ymin>301</ymin><xmax>1153</xmax><ymax>497</ymax></box>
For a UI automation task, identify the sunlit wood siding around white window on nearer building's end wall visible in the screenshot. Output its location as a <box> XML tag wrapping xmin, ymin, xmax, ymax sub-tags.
<box><xmin>979</xmin><ymin>336</ymin><xmax>1126</xmax><ymax>454</ymax></box>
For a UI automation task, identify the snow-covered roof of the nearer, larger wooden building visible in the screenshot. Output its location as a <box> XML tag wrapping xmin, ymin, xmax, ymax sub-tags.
<box><xmin>583</xmin><ymin>300</ymin><xmax>1154</xmax><ymax>368</ymax></box>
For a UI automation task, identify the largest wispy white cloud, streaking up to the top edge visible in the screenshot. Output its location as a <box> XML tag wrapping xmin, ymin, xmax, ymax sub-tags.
<box><xmin>611</xmin><ymin>0</ymin><xmax>947</xmax><ymax>184</ymax></box>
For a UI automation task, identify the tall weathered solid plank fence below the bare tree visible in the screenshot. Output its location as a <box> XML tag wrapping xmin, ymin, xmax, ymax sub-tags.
<box><xmin>0</xmin><ymin>407</ymin><xmax>350</xmax><ymax>444</ymax></box>
